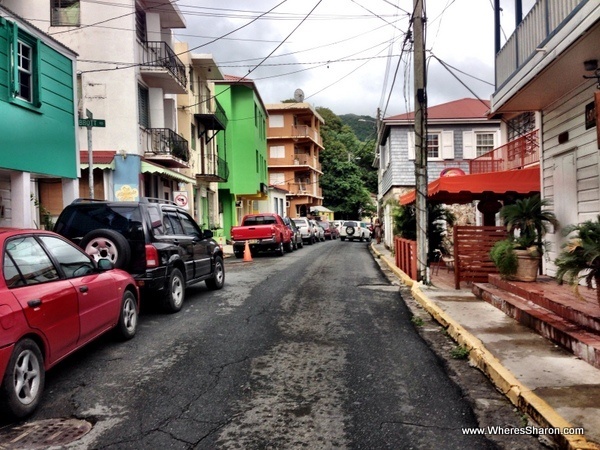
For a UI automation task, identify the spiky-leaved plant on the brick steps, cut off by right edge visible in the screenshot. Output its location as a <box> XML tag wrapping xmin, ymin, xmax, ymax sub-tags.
<box><xmin>554</xmin><ymin>215</ymin><xmax>600</xmax><ymax>305</ymax></box>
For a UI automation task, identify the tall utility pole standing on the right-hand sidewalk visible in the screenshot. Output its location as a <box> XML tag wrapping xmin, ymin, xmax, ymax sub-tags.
<box><xmin>413</xmin><ymin>0</ymin><xmax>429</xmax><ymax>284</ymax></box>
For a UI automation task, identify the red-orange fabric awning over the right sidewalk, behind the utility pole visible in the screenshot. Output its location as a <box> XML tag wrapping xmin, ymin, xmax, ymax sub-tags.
<box><xmin>400</xmin><ymin>166</ymin><xmax>540</xmax><ymax>205</ymax></box>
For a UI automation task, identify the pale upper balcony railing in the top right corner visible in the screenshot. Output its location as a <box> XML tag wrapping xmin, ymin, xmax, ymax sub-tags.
<box><xmin>496</xmin><ymin>0</ymin><xmax>587</xmax><ymax>89</ymax></box>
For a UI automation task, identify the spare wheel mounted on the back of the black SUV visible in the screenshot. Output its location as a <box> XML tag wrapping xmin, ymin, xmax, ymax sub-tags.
<box><xmin>79</xmin><ymin>229</ymin><xmax>131</xmax><ymax>269</ymax></box>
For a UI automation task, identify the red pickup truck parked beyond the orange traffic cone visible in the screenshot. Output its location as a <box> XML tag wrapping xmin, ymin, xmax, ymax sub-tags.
<box><xmin>231</xmin><ymin>213</ymin><xmax>293</xmax><ymax>258</ymax></box>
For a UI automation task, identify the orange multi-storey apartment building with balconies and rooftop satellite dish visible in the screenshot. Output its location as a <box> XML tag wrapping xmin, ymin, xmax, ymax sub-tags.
<box><xmin>266</xmin><ymin>103</ymin><xmax>324</xmax><ymax>217</ymax></box>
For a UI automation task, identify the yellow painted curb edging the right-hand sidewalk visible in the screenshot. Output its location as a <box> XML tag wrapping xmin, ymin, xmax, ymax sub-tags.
<box><xmin>371</xmin><ymin>245</ymin><xmax>600</xmax><ymax>450</ymax></box>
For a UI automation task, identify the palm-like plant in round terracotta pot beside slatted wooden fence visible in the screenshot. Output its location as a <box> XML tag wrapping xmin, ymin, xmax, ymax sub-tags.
<box><xmin>490</xmin><ymin>195</ymin><xmax>558</xmax><ymax>281</ymax></box>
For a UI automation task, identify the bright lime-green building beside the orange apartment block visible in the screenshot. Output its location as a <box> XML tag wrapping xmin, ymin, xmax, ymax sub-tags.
<box><xmin>215</xmin><ymin>76</ymin><xmax>268</xmax><ymax>239</ymax></box>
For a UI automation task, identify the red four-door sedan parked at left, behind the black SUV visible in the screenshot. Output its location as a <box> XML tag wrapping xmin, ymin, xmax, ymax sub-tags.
<box><xmin>0</xmin><ymin>228</ymin><xmax>139</xmax><ymax>418</ymax></box>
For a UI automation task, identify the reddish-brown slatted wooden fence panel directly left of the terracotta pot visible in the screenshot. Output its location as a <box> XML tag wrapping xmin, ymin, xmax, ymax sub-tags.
<box><xmin>454</xmin><ymin>226</ymin><xmax>507</xmax><ymax>289</ymax></box>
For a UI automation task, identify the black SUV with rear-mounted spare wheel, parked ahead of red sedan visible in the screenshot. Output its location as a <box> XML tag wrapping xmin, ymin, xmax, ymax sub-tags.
<box><xmin>54</xmin><ymin>198</ymin><xmax>225</xmax><ymax>312</ymax></box>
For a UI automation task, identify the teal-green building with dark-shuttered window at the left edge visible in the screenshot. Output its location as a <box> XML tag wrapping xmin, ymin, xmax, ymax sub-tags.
<box><xmin>0</xmin><ymin>6</ymin><xmax>78</xmax><ymax>227</ymax></box>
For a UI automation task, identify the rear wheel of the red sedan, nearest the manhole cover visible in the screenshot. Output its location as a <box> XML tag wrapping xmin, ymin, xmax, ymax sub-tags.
<box><xmin>1</xmin><ymin>339</ymin><xmax>46</xmax><ymax>418</ymax></box>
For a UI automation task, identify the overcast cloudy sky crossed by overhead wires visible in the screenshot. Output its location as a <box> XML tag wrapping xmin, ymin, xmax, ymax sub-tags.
<box><xmin>176</xmin><ymin>0</ymin><xmax>535</xmax><ymax>117</ymax></box>
